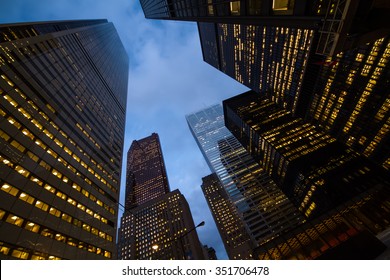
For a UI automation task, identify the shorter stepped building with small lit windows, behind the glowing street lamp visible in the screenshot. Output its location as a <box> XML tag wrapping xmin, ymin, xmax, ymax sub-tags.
<box><xmin>118</xmin><ymin>190</ymin><xmax>204</xmax><ymax>260</ymax></box>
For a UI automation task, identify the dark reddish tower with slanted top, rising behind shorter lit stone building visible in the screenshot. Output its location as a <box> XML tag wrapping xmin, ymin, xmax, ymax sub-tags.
<box><xmin>125</xmin><ymin>133</ymin><xmax>170</xmax><ymax>210</ymax></box>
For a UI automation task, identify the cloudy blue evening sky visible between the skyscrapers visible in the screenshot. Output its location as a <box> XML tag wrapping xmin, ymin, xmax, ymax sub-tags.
<box><xmin>0</xmin><ymin>0</ymin><xmax>247</xmax><ymax>259</ymax></box>
